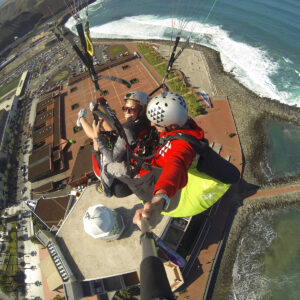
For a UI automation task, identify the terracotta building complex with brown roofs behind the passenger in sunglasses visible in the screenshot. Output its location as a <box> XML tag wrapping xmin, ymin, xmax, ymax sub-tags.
<box><xmin>28</xmin><ymin>47</ymin><xmax>158</xmax><ymax>187</ymax></box>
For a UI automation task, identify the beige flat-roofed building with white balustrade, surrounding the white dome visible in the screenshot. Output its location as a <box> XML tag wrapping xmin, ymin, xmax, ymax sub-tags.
<box><xmin>37</xmin><ymin>185</ymin><xmax>186</xmax><ymax>299</ymax></box>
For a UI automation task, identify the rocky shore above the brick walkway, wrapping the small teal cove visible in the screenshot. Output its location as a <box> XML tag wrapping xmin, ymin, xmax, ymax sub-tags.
<box><xmin>188</xmin><ymin>41</ymin><xmax>300</xmax><ymax>188</ymax></box>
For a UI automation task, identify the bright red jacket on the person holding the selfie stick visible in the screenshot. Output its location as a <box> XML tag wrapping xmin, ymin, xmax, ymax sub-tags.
<box><xmin>140</xmin><ymin>122</ymin><xmax>204</xmax><ymax>197</ymax></box>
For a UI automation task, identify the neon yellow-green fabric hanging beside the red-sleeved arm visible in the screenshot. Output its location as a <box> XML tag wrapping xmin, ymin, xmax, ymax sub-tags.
<box><xmin>162</xmin><ymin>162</ymin><xmax>230</xmax><ymax>218</ymax></box>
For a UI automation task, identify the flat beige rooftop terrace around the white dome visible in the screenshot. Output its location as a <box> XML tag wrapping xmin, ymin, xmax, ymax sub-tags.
<box><xmin>56</xmin><ymin>185</ymin><xmax>169</xmax><ymax>280</ymax></box>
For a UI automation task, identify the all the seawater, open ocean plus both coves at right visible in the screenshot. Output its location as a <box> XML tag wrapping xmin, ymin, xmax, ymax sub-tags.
<box><xmin>65</xmin><ymin>0</ymin><xmax>300</xmax><ymax>300</ymax></box>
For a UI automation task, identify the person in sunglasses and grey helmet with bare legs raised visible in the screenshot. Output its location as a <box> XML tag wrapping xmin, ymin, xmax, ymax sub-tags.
<box><xmin>77</xmin><ymin>91</ymin><xmax>150</xmax><ymax>197</ymax></box>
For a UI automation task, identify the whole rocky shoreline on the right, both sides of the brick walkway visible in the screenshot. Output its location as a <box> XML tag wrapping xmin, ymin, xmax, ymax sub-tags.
<box><xmin>135</xmin><ymin>41</ymin><xmax>300</xmax><ymax>299</ymax></box>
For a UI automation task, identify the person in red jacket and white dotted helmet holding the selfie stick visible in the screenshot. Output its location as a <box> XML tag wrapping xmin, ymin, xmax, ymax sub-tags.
<box><xmin>107</xmin><ymin>92</ymin><xmax>239</xmax><ymax>225</ymax></box>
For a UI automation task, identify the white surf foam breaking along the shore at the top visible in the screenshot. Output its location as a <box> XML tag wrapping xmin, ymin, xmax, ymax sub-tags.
<box><xmin>66</xmin><ymin>13</ymin><xmax>300</xmax><ymax>105</ymax></box>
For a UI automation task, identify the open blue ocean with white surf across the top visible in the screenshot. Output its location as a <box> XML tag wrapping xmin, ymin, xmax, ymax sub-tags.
<box><xmin>66</xmin><ymin>0</ymin><xmax>300</xmax><ymax>106</ymax></box>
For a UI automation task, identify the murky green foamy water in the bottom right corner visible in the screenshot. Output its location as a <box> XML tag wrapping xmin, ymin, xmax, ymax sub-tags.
<box><xmin>229</xmin><ymin>208</ymin><xmax>300</xmax><ymax>300</ymax></box>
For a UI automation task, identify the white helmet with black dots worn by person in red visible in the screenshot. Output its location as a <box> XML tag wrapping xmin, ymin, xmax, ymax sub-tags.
<box><xmin>147</xmin><ymin>92</ymin><xmax>188</xmax><ymax>127</ymax></box>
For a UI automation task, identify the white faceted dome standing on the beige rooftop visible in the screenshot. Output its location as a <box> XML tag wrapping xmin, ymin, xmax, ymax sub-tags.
<box><xmin>83</xmin><ymin>204</ymin><xmax>124</xmax><ymax>240</ymax></box>
